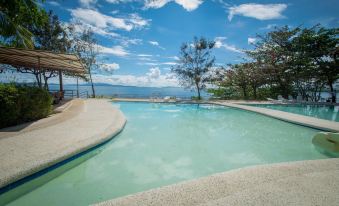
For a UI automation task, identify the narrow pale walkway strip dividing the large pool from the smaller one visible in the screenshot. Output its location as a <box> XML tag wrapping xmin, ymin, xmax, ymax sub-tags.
<box><xmin>210</xmin><ymin>101</ymin><xmax>339</xmax><ymax>132</ymax></box>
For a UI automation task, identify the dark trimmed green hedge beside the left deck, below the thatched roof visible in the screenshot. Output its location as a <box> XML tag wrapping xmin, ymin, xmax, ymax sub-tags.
<box><xmin>0</xmin><ymin>84</ymin><xmax>52</xmax><ymax>128</ymax></box>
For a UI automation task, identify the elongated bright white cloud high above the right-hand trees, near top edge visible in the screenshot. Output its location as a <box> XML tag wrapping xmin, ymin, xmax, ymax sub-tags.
<box><xmin>228</xmin><ymin>3</ymin><xmax>287</xmax><ymax>21</ymax></box>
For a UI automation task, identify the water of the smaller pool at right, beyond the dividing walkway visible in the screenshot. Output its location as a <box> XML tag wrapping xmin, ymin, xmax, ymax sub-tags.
<box><xmin>246</xmin><ymin>104</ymin><xmax>339</xmax><ymax>122</ymax></box>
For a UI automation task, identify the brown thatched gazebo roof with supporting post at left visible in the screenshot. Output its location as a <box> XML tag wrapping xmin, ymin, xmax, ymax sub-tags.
<box><xmin>0</xmin><ymin>47</ymin><xmax>85</xmax><ymax>92</ymax></box>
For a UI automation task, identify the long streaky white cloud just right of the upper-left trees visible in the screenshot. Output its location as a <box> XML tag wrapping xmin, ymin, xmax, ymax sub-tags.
<box><xmin>70</xmin><ymin>8</ymin><xmax>149</xmax><ymax>31</ymax></box>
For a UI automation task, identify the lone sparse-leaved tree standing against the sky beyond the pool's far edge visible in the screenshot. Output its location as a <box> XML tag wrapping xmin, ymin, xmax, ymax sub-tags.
<box><xmin>171</xmin><ymin>37</ymin><xmax>215</xmax><ymax>100</ymax></box>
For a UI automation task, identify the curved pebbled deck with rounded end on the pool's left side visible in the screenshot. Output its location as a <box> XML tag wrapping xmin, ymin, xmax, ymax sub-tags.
<box><xmin>0</xmin><ymin>99</ymin><xmax>126</xmax><ymax>188</ymax></box>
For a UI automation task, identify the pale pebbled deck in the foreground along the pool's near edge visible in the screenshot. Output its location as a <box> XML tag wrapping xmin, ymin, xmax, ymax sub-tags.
<box><xmin>98</xmin><ymin>158</ymin><xmax>339</xmax><ymax>206</ymax></box>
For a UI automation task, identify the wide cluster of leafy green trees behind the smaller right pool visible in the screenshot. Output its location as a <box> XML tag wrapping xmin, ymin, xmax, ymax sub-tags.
<box><xmin>213</xmin><ymin>25</ymin><xmax>339</xmax><ymax>102</ymax></box>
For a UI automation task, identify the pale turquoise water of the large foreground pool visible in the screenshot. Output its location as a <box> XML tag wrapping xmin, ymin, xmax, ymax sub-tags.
<box><xmin>0</xmin><ymin>102</ymin><xmax>328</xmax><ymax>206</ymax></box>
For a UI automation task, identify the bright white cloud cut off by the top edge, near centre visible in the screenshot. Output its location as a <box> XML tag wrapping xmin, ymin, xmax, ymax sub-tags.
<box><xmin>144</xmin><ymin>0</ymin><xmax>203</xmax><ymax>11</ymax></box>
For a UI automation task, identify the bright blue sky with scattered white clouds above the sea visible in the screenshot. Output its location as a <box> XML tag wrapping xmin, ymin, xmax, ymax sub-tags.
<box><xmin>2</xmin><ymin>0</ymin><xmax>339</xmax><ymax>87</ymax></box>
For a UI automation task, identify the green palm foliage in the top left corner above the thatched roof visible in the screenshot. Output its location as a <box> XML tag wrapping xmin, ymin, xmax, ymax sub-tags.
<box><xmin>0</xmin><ymin>0</ymin><xmax>47</xmax><ymax>48</ymax></box>
